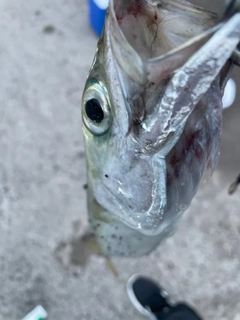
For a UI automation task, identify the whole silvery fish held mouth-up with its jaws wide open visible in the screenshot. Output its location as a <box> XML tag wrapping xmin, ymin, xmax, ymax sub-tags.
<box><xmin>82</xmin><ymin>0</ymin><xmax>240</xmax><ymax>257</ymax></box>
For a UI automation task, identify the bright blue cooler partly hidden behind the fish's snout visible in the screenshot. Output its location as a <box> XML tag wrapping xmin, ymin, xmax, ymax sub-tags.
<box><xmin>88</xmin><ymin>0</ymin><xmax>108</xmax><ymax>36</ymax></box>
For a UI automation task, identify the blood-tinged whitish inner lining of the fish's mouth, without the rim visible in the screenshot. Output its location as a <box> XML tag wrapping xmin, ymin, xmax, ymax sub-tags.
<box><xmin>110</xmin><ymin>0</ymin><xmax>218</xmax><ymax>61</ymax></box>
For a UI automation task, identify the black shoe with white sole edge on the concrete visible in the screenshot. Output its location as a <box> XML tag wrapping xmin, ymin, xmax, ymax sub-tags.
<box><xmin>127</xmin><ymin>274</ymin><xmax>201</xmax><ymax>320</ymax></box>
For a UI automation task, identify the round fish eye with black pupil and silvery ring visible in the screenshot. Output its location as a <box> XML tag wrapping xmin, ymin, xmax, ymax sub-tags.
<box><xmin>82</xmin><ymin>82</ymin><xmax>112</xmax><ymax>135</ymax></box>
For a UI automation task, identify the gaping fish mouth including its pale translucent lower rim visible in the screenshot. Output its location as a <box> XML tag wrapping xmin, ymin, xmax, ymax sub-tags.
<box><xmin>108</xmin><ymin>0</ymin><xmax>219</xmax><ymax>85</ymax></box>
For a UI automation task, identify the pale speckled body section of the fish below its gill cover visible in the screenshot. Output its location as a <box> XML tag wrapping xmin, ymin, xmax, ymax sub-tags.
<box><xmin>88</xmin><ymin>179</ymin><xmax>180</xmax><ymax>258</ymax></box>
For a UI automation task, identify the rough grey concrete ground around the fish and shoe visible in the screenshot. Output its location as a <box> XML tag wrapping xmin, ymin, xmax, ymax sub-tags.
<box><xmin>0</xmin><ymin>0</ymin><xmax>240</xmax><ymax>320</ymax></box>
